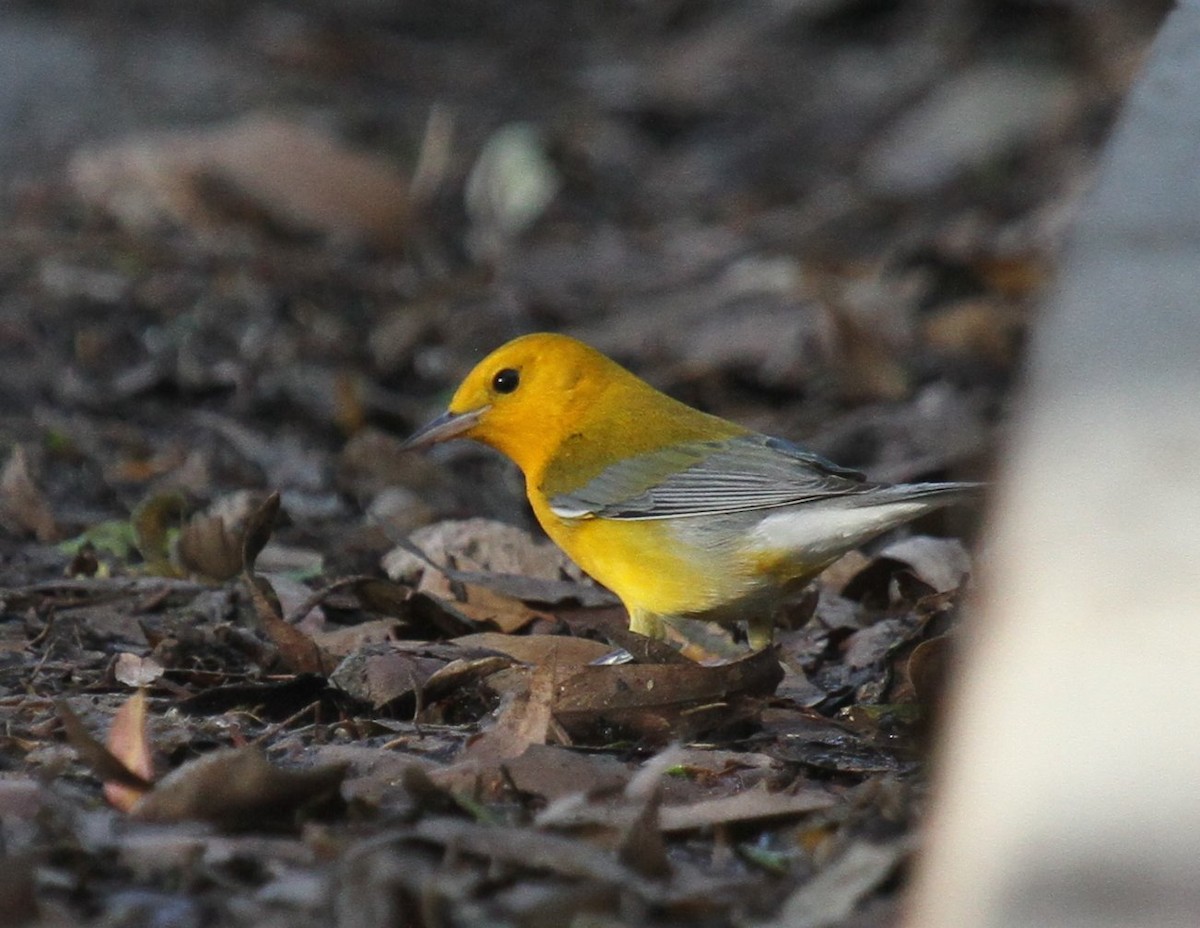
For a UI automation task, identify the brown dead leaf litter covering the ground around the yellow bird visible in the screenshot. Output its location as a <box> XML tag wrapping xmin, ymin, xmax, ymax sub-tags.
<box><xmin>0</xmin><ymin>2</ymin><xmax>1165</xmax><ymax>928</ymax></box>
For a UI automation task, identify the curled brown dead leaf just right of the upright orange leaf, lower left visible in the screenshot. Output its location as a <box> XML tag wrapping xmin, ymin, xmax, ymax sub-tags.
<box><xmin>132</xmin><ymin>747</ymin><xmax>347</xmax><ymax>831</ymax></box>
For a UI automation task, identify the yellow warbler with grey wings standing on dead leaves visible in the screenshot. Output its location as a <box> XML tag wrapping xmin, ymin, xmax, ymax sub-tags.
<box><xmin>406</xmin><ymin>334</ymin><xmax>978</xmax><ymax>647</ymax></box>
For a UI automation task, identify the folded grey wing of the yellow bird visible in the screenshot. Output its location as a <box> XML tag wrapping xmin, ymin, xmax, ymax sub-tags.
<box><xmin>550</xmin><ymin>435</ymin><xmax>871</xmax><ymax>520</ymax></box>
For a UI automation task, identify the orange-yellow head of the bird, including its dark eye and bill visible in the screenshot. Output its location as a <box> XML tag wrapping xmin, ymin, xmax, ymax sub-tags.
<box><xmin>406</xmin><ymin>333</ymin><xmax>619</xmax><ymax>474</ymax></box>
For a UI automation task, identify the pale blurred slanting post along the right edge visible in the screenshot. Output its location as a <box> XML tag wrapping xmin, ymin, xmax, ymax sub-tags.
<box><xmin>906</xmin><ymin>0</ymin><xmax>1200</xmax><ymax>928</ymax></box>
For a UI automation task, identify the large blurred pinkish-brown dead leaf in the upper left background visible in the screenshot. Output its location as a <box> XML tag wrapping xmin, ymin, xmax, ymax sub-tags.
<box><xmin>70</xmin><ymin>114</ymin><xmax>409</xmax><ymax>247</ymax></box>
